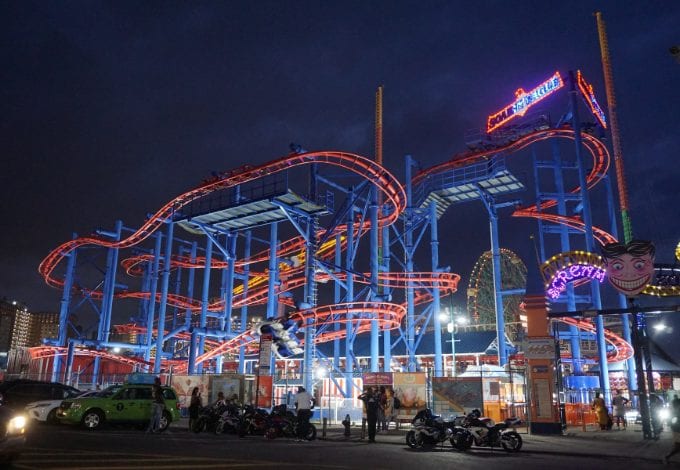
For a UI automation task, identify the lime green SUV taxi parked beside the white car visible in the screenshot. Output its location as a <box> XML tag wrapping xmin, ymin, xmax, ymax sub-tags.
<box><xmin>57</xmin><ymin>384</ymin><xmax>180</xmax><ymax>431</ymax></box>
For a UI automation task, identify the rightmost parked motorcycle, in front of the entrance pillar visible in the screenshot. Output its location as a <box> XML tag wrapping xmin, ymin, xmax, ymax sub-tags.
<box><xmin>450</xmin><ymin>409</ymin><xmax>522</xmax><ymax>452</ymax></box>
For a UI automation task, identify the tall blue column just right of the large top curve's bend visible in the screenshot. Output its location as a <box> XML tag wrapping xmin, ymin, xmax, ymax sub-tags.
<box><xmin>404</xmin><ymin>155</ymin><xmax>416</xmax><ymax>372</ymax></box>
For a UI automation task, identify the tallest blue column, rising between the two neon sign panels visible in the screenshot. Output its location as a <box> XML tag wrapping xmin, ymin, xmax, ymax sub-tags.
<box><xmin>569</xmin><ymin>70</ymin><xmax>611</xmax><ymax>404</ymax></box>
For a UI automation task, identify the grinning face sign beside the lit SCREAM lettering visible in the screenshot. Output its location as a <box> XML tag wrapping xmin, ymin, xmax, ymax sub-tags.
<box><xmin>602</xmin><ymin>240</ymin><xmax>655</xmax><ymax>297</ymax></box>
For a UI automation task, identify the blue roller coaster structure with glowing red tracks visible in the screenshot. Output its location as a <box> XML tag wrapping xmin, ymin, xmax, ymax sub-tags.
<box><xmin>31</xmin><ymin>69</ymin><xmax>632</xmax><ymax>392</ymax></box>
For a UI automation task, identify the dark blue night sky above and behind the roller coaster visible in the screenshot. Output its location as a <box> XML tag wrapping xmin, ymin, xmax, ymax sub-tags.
<box><xmin>0</xmin><ymin>0</ymin><xmax>680</xmax><ymax>348</ymax></box>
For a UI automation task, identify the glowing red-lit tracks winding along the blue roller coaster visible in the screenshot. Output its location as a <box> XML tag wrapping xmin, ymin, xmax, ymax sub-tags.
<box><xmin>32</xmin><ymin>129</ymin><xmax>632</xmax><ymax>370</ymax></box>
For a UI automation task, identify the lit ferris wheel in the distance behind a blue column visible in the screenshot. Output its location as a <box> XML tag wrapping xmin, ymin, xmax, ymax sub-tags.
<box><xmin>467</xmin><ymin>248</ymin><xmax>527</xmax><ymax>340</ymax></box>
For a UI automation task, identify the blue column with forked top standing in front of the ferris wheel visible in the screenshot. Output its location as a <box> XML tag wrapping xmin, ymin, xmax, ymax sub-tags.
<box><xmin>477</xmin><ymin>191</ymin><xmax>515</xmax><ymax>367</ymax></box>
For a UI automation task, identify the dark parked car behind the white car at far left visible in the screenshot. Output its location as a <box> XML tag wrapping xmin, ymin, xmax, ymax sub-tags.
<box><xmin>0</xmin><ymin>379</ymin><xmax>81</xmax><ymax>411</ymax></box>
